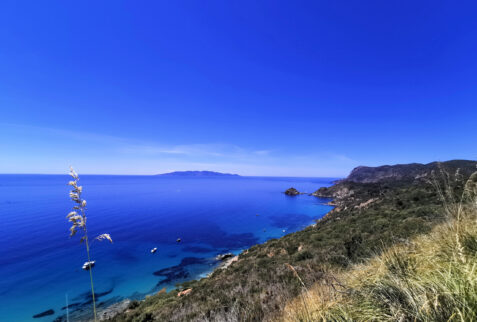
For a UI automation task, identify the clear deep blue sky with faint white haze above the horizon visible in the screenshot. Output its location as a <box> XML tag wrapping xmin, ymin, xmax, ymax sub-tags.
<box><xmin>0</xmin><ymin>0</ymin><xmax>477</xmax><ymax>176</ymax></box>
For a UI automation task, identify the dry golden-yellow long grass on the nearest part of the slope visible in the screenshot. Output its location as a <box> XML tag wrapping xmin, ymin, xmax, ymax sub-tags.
<box><xmin>283</xmin><ymin>173</ymin><xmax>477</xmax><ymax>321</ymax></box>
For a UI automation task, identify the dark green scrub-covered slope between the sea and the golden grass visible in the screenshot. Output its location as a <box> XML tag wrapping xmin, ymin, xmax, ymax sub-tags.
<box><xmin>115</xmin><ymin>163</ymin><xmax>475</xmax><ymax>321</ymax></box>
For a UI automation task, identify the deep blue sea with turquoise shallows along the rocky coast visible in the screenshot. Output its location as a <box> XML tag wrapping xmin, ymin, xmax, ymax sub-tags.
<box><xmin>0</xmin><ymin>175</ymin><xmax>333</xmax><ymax>321</ymax></box>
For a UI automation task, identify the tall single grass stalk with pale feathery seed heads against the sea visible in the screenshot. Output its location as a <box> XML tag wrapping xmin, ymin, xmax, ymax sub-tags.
<box><xmin>66</xmin><ymin>167</ymin><xmax>113</xmax><ymax>321</ymax></box>
